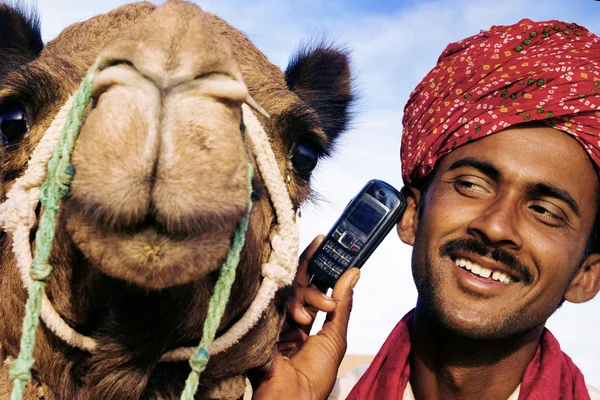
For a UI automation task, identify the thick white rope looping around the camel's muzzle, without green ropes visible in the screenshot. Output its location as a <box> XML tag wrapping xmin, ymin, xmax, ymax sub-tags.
<box><xmin>0</xmin><ymin>97</ymin><xmax>298</xmax><ymax>361</ymax></box>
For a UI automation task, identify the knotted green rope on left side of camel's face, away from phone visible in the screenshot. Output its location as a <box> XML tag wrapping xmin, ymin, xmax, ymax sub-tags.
<box><xmin>9</xmin><ymin>67</ymin><xmax>94</xmax><ymax>400</ymax></box>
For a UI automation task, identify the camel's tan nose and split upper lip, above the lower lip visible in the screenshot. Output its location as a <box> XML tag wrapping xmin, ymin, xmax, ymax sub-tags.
<box><xmin>72</xmin><ymin>0</ymin><xmax>251</xmax><ymax>231</ymax></box>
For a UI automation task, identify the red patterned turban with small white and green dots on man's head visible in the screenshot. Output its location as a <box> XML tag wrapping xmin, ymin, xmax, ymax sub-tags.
<box><xmin>400</xmin><ymin>19</ymin><xmax>600</xmax><ymax>184</ymax></box>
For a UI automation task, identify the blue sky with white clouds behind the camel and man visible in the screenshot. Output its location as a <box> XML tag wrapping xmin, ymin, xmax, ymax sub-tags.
<box><xmin>38</xmin><ymin>0</ymin><xmax>600</xmax><ymax>387</ymax></box>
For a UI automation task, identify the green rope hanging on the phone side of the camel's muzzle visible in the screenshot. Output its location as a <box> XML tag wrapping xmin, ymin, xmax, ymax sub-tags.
<box><xmin>181</xmin><ymin>164</ymin><xmax>253</xmax><ymax>400</ymax></box>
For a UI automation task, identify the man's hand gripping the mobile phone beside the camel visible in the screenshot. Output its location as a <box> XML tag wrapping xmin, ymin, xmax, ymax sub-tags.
<box><xmin>253</xmin><ymin>236</ymin><xmax>360</xmax><ymax>400</ymax></box>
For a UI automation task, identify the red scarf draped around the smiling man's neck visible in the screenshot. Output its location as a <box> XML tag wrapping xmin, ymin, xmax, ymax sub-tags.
<box><xmin>347</xmin><ymin>310</ymin><xmax>590</xmax><ymax>400</ymax></box>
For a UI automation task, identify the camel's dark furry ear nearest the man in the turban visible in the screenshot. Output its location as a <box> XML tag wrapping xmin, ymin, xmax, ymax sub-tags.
<box><xmin>285</xmin><ymin>45</ymin><xmax>354</xmax><ymax>149</ymax></box>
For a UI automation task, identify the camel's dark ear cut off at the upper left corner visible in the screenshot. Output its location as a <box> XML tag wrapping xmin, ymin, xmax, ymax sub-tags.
<box><xmin>0</xmin><ymin>3</ymin><xmax>44</xmax><ymax>76</ymax></box>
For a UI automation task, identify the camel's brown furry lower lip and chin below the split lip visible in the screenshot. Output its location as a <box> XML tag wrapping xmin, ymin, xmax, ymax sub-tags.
<box><xmin>64</xmin><ymin>197</ymin><xmax>243</xmax><ymax>289</ymax></box>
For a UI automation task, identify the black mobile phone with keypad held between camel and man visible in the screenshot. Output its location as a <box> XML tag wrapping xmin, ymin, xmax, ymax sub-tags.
<box><xmin>308</xmin><ymin>179</ymin><xmax>406</xmax><ymax>288</ymax></box>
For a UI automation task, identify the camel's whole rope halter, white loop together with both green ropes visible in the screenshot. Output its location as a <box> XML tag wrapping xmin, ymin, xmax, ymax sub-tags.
<box><xmin>0</xmin><ymin>65</ymin><xmax>298</xmax><ymax>400</ymax></box>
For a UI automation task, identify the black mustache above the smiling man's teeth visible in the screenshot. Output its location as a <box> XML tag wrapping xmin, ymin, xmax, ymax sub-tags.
<box><xmin>440</xmin><ymin>238</ymin><xmax>533</xmax><ymax>285</ymax></box>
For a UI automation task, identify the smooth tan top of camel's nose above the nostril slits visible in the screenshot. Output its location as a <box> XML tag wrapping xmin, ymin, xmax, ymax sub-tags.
<box><xmin>97</xmin><ymin>0</ymin><xmax>243</xmax><ymax>91</ymax></box>
